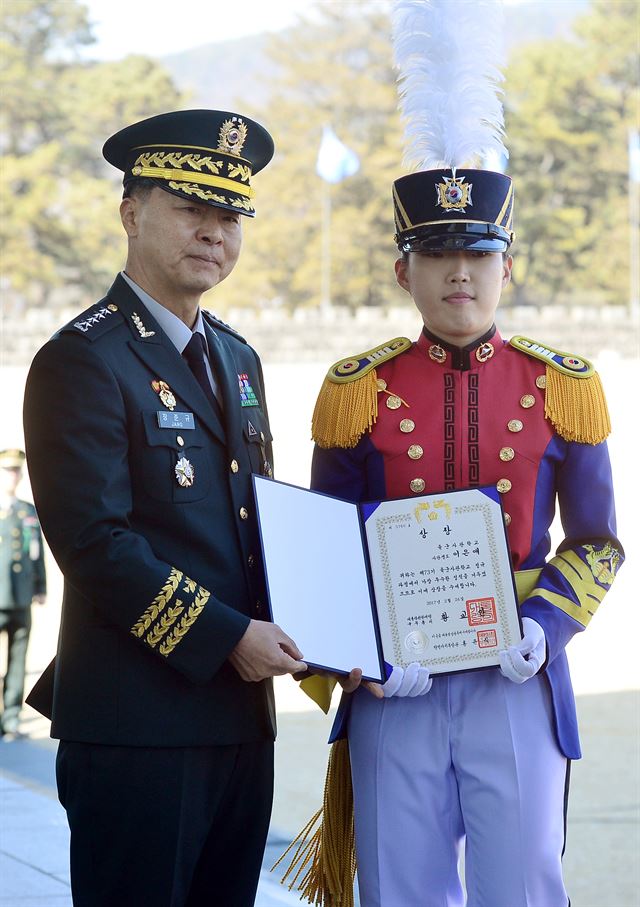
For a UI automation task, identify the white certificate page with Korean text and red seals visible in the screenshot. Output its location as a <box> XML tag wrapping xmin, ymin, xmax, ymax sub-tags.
<box><xmin>361</xmin><ymin>486</ymin><xmax>522</xmax><ymax>674</ymax></box>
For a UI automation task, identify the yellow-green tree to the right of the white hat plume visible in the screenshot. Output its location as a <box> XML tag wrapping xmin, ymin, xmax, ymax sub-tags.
<box><xmin>506</xmin><ymin>0</ymin><xmax>638</xmax><ymax>305</ymax></box>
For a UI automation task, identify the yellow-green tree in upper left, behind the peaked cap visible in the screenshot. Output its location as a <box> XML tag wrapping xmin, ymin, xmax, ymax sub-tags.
<box><xmin>0</xmin><ymin>0</ymin><xmax>181</xmax><ymax>310</ymax></box>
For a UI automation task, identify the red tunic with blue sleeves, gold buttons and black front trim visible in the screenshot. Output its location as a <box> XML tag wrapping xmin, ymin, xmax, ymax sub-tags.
<box><xmin>312</xmin><ymin>328</ymin><xmax>622</xmax><ymax>759</ymax></box>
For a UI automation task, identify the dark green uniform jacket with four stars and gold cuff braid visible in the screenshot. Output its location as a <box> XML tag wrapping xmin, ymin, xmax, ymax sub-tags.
<box><xmin>25</xmin><ymin>277</ymin><xmax>275</xmax><ymax>746</ymax></box>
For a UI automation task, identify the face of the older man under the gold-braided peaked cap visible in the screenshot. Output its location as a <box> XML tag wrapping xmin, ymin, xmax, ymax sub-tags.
<box><xmin>120</xmin><ymin>188</ymin><xmax>242</xmax><ymax>303</ymax></box>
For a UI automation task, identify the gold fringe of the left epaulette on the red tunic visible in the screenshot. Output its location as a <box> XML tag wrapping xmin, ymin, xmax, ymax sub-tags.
<box><xmin>311</xmin><ymin>369</ymin><xmax>378</xmax><ymax>447</ymax></box>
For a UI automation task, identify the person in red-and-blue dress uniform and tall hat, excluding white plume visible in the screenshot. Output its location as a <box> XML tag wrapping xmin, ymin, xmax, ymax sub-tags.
<box><xmin>305</xmin><ymin>168</ymin><xmax>623</xmax><ymax>907</ymax></box>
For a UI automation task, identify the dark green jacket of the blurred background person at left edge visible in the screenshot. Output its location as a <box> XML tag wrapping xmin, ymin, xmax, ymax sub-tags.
<box><xmin>0</xmin><ymin>498</ymin><xmax>47</xmax><ymax>611</ymax></box>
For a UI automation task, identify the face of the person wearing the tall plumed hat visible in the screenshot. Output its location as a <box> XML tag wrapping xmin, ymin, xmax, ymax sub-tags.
<box><xmin>396</xmin><ymin>251</ymin><xmax>512</xmax><ymax>347</ymax></box>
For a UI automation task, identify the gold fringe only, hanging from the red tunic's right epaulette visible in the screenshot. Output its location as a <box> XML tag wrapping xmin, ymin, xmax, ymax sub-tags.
<box><xmin>544</xmin><ymin>366</ymin><xmax>611</xmax><ymax>444</ymax></box>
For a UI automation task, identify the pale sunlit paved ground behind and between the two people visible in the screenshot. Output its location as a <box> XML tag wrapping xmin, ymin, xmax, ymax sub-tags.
<box><xmin>0</xmin><ymin>354</ymin><xmax>640</xmax><ymax>907</ymax></box>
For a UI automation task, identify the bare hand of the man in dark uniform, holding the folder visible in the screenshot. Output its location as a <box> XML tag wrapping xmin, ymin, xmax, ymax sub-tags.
<box><xmin>228</xmin><ymin>620</ymin><xmax>307</xmax><ymax>682</ymax></box>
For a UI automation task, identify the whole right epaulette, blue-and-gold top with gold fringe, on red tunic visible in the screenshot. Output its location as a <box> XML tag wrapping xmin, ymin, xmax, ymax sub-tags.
<box><xmin>509</xmin><ymin>335</ymin><xmax>611</xmax><ymax>444</ymax></box>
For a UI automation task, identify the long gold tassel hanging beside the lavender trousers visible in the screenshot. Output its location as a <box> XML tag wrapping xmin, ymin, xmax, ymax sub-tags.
<box><xmin>272</xmin><ymin>740</ymin><xmax>356</xmax><ymax>907</ymax></box>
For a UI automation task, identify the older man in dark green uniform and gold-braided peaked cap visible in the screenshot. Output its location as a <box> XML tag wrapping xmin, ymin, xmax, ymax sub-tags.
<box><xmin>25</xmin><ymin>110</ymin><xmax>301</xmax><ymax>907</ymax></box>
